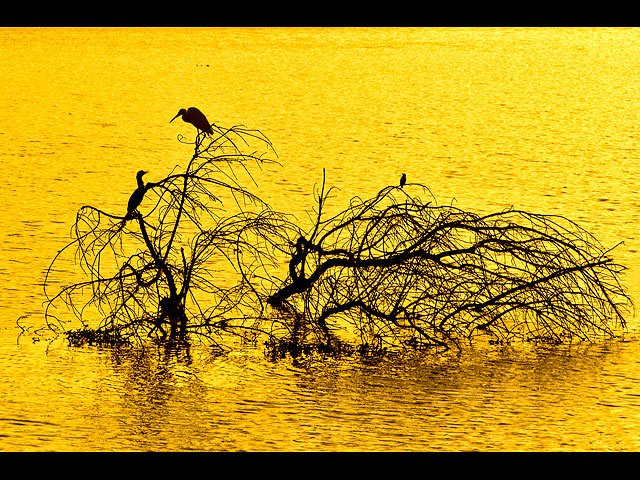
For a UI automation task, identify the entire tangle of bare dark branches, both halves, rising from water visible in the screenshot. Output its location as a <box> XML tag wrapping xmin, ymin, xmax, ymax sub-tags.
<box><xmin>45</xmin><ymin>124</ymin><xmax>631</xmax><ymax>357</ymax></box>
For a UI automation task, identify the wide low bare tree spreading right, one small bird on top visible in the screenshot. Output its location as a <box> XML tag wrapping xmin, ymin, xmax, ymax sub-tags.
<box><xmin>269</xmin><ymin>172</ymin><xmax>630</xmax><ymax>350</ymax></box>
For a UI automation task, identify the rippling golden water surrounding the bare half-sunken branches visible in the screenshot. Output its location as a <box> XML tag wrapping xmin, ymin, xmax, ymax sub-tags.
<box><xmin>0</xmin><ymin>28</ymin><xmax>640</xmax><ymax>450</ymax></box>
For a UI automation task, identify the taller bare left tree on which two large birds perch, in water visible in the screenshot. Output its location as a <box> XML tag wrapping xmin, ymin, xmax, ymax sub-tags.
<box><xmin>45</xmin><ymin>124</ymin><xmax>298</xmax><ymax>348</ymax></box>
